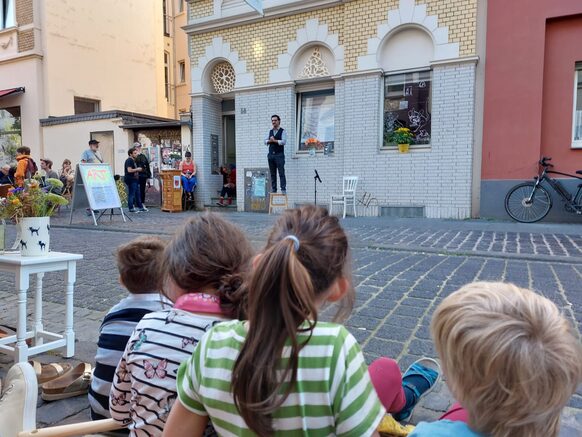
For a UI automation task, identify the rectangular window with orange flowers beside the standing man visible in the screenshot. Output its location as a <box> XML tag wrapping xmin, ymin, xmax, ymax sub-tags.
<box><xmin>297</xmin><ymin>90</ymin><xmax>335</xmax><ymax>151</ymax></box>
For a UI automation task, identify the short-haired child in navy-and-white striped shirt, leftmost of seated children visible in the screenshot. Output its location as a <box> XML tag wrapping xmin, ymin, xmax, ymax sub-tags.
<box><xmin>89</xmin><ymin>237</ymin><xmax>168</xmax><ymax>420</ymax></box>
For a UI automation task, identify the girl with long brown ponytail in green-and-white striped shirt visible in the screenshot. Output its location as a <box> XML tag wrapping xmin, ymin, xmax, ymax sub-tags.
<box><xmin>164</xmin><ymin>206</ymin><xmax>384</xmax><ymax>437</ymax></box>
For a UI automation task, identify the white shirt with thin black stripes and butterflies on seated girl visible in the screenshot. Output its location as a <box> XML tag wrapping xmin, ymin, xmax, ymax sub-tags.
<box><xmin>109</xmin><ymin>308</ymin><xmax>228</xmax><ymax>436</ymax></box>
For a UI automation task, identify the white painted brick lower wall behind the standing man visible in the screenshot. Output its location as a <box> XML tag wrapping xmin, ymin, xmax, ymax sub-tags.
<box><xmin>193</xmin><ymin>64</ymin><xmax>475</xmax><ymax>218</ymax></box>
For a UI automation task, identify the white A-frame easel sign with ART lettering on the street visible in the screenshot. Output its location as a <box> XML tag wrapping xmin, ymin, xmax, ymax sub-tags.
<box><xmin>69</xmin><ymin>164</ymin><xmax>125</xmax><ymax>226</ymax></box>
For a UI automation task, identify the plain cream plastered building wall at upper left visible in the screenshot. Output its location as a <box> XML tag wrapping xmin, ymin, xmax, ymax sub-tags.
<box><xmin>42</xmin><ymin>0</ymin><xmax>168</xmax><ymax>116</ymax></box>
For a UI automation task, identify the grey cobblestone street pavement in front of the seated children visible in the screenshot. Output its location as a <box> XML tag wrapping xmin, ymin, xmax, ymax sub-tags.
<box><xmin>0</xmin><ymin>211</ymin><xmax>582</xmax><ymax>436</ymax></box>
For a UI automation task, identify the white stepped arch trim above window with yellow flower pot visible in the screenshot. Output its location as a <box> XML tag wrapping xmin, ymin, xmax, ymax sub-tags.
<box><xmin>358</xmin><ymin>0</ymin><xmax>459</xmax><ymax>70</ymax></box>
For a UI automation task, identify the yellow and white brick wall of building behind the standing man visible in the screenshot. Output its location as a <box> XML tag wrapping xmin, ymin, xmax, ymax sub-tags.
<box><xmin>189</xmin><ymin>0</ymin><xmax>477</xmax><ymax>218</ymax></box>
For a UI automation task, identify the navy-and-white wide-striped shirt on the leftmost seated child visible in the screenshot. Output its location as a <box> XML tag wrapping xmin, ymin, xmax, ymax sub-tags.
<box><xmin>89</xmin><ymin>293</ymin><xmax>172</xmax><ymax>420</ymax></box>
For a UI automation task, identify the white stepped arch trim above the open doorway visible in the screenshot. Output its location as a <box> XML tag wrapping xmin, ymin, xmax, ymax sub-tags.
<box><xmin>191</xmin><ymin>36</ymin><xmax>255</xmax><ymax>93</ymax></box>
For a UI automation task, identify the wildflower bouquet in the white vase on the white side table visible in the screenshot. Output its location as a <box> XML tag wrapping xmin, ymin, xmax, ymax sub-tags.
<box><xmin>0</xmin><ymin>178</ymin><xmax>69</xmax><ymax>222</ymax></box>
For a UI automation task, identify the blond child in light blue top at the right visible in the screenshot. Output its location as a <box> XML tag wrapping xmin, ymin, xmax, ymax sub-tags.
<box><xmin>411</xmin><ymin>282</ymin><xmax>582</xmax><ymax>437</ymax></box>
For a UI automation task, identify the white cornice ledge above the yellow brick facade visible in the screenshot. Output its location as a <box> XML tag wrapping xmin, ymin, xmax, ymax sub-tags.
<box><xmin>182</xmin><ymin>0</ymin><xmax>352</xmax><ymax>35</ymax></box>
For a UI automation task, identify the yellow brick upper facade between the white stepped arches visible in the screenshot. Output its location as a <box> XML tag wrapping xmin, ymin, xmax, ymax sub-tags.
<box><xmin>190</xmin><ymin>0</ymin><xmax>477</xmax><ymax>85</ymax></box>
